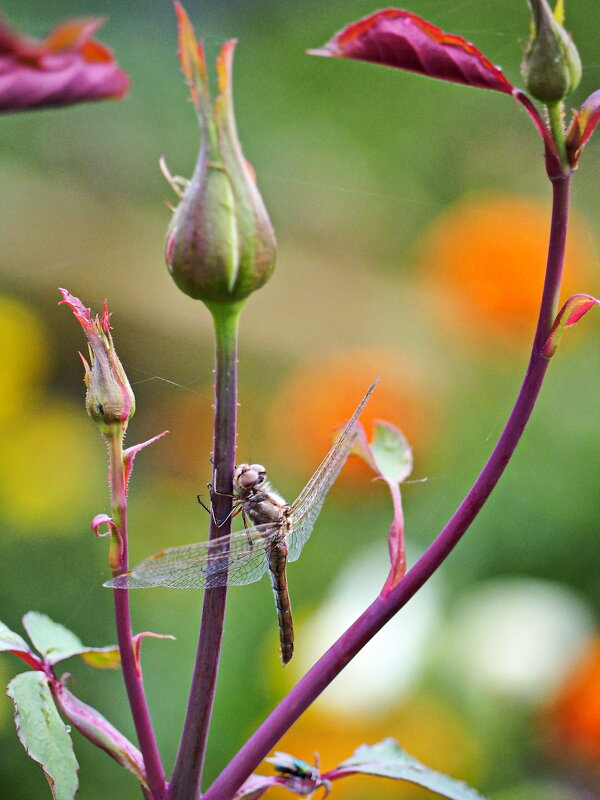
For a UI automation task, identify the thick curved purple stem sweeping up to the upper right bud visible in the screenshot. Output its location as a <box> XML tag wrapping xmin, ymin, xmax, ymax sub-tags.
<box><xmin>202</xmin><ymin>175</ymin><xmax>570</xmax><ymax>800</ymax></box>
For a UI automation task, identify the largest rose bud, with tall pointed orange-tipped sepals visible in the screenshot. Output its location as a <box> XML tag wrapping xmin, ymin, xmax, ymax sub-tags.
<box><xmin>166</xmin><ymin>3</ymin><xmax>276</xmax><ymax>303</ymax></box>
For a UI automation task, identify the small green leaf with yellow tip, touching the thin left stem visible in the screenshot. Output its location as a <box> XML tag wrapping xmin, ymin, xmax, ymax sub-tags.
<box><xmin>23</xmin><ymin>611</ymin><xmax>119</xmax><ymax>669</ymax></box>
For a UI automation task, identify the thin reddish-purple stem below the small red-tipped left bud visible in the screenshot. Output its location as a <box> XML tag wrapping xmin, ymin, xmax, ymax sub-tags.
<box><xmin>107</xmin><ymin>431</ymin><xmax>167</xmax><ymax>800</ymax></box>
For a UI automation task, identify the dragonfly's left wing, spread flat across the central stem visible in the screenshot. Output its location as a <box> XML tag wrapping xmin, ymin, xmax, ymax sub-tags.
<box><xmin>104</xmin><ymin>523</ymin><xmax>281</xmax><ymax>589</ymax></box>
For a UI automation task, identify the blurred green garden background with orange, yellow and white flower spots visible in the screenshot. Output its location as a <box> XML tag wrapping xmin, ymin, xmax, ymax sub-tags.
<box><xmin>0</xmin><ymin>0</ymin><xmax>600</xmax><ymax>800</ymax></box>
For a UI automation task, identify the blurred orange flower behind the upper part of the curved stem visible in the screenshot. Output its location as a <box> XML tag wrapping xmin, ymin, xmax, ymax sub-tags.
<box><xmin>418</xmin><ymin>195</ymin><xmax>595</xmax><ymax>344</ymax></box>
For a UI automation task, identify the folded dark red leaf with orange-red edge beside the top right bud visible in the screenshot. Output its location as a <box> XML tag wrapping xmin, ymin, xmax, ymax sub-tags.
<box><xmin>309</xmin><ymin>8</ymin><xmax>514</xmax><ymax>94</ymax></box>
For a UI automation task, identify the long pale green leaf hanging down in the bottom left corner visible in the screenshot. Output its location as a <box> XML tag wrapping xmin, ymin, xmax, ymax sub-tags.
<box><xmin>6</xmin><ymin>671</ymin><xmax>79</xmax><ymax>800</ymax></box>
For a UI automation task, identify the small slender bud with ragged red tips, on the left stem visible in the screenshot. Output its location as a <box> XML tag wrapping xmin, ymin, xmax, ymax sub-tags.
<box><xmin>60</xmin><ymin>289</ymin><xmax>135</xmax><ymax>434</ymax></box>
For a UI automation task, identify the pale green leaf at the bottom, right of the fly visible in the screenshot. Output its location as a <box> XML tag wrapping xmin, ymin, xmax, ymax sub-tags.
<box><xmin>336</xmin><ymin>739</ymin><xmax>483</xmax><ymax>800</ymax></box>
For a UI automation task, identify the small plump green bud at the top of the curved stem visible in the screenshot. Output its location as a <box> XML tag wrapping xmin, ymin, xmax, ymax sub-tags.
<box><xmin>521</xmin><ymin>0</ymin><xmax>581</xmax><ymax>103</ymax></box>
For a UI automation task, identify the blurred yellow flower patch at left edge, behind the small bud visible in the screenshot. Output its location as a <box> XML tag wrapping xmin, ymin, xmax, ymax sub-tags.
<box><xmin>0</xmin><ymin>296</ymin><xmax>103</xmax><ymax>536</ymax></box>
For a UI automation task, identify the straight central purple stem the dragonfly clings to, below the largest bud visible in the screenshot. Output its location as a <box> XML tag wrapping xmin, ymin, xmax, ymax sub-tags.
<box><xmin>168</xmin><ymin>305</ymin><xmax>241</xmax><ymax>800</ymax></box>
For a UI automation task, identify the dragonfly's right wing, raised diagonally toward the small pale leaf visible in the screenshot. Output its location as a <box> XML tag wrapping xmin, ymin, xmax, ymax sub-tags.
<box><xmin>288</xmin><ymin>381</ymin><xmax>377</xmax><ymax>561</ymax></box>
